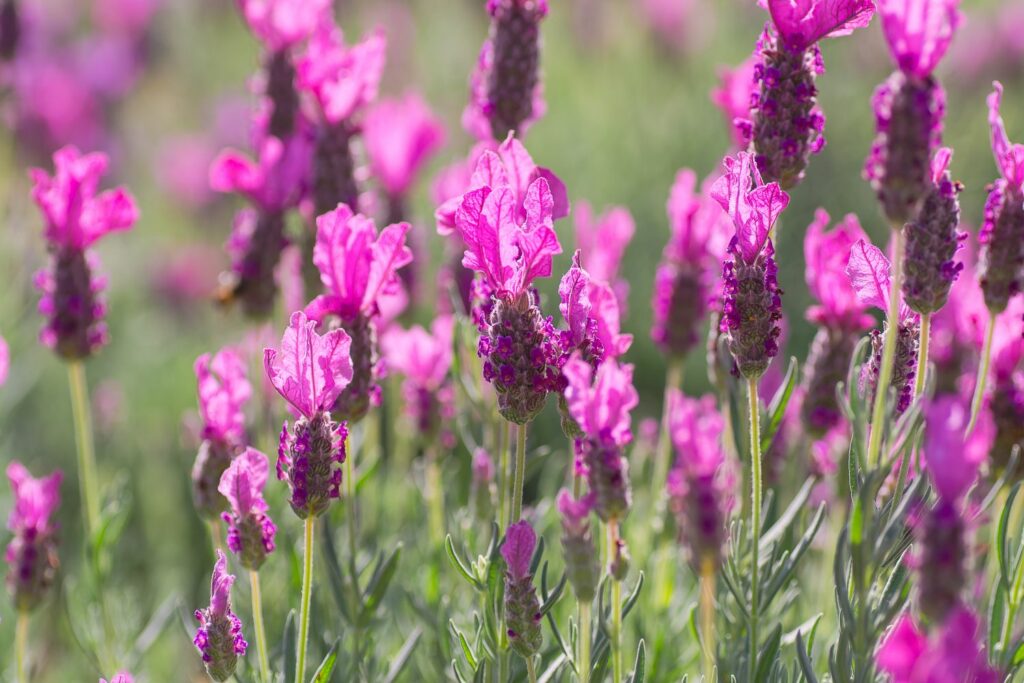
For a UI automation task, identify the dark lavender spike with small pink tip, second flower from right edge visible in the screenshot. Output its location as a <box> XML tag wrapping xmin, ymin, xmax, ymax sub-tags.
<box><xmin>903</xmin><ymin>147</ymin><xmax>968</xmax><ymax>314</ymax></box>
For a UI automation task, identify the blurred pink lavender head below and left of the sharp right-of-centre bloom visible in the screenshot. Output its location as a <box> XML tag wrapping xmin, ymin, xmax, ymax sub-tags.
<box><xmin>667</xmin><ymin>389</ymin><xmax>732</xmax><ymax>571</ymax></box>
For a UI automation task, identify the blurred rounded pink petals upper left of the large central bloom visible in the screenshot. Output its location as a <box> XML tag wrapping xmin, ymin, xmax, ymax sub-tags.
<box><xmin>362</xmin><ymin>92</ymin><xmax>444</xmax><ymax>202</ymax></box>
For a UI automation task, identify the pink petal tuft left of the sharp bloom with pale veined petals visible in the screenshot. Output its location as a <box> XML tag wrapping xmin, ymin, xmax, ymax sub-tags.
<box><xmin>194</xmin><ymin>348</ymin><xmax>252</xmax><ymax>444</ymax></box>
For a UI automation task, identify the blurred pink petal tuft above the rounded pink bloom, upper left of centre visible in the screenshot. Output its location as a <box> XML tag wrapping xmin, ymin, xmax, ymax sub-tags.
<box><xmin>296</xmin><ymin>22</ymin><xmax>387</xmax><ymax>125</ymax></box>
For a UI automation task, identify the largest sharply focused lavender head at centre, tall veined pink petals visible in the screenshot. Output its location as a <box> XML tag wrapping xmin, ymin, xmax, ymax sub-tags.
<box><xmin>455</xmin><ymin>150</ymin><xmax>562</xmax><ymax>424</ymax></box>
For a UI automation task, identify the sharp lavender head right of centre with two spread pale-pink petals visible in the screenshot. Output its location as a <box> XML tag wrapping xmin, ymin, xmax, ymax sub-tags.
<box><xmin>712</xmin><ymin>153</ymin><xmax>790</xmax><ymax>379</ymax></box>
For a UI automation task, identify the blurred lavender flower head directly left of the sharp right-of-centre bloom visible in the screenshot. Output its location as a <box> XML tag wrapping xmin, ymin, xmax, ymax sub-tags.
<box><xmin>650</xmin><ymin>168</ymin><xmax>731</xmax><ymax>358</ymax></box>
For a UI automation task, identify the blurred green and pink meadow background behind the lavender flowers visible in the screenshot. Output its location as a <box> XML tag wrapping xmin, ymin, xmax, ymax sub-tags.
<box><xmin>0</xmin><ymin>0</ymin><xmax>1024</xmax><ymax>681</ymax></box>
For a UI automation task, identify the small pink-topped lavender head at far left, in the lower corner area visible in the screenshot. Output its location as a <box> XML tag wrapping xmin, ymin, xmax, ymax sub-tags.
<box><xmin>4</xmin><ymin>460</ymin><xmax>63</xmax><ymax>610</ymax></box>
